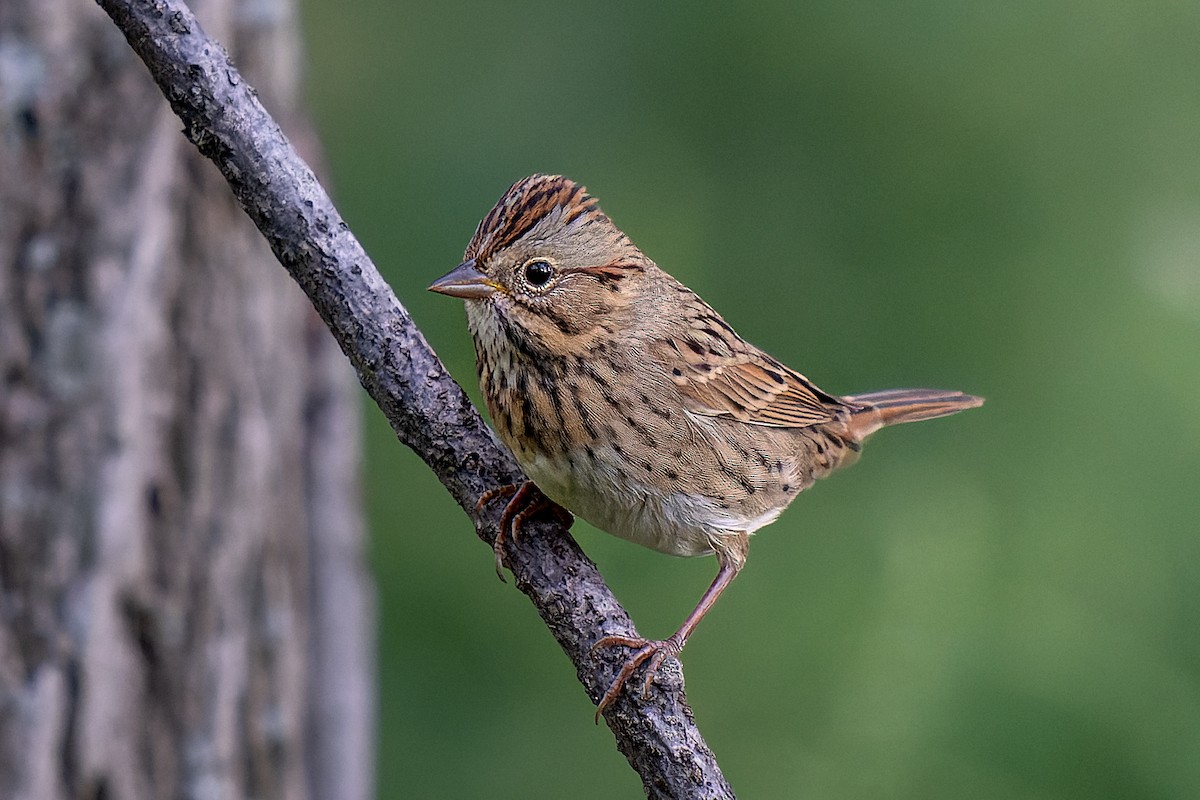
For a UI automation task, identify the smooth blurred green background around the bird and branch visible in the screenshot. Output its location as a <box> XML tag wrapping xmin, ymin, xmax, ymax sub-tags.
<box><xmin>297</xmin><ymin>0</ymin><xmax>1200</xmax><ymax>799</ymax></box>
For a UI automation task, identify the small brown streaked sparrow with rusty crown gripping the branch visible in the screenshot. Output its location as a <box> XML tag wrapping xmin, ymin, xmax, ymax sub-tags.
<box><xmin>430</xmin><ymin>175</ymin><xmax>983</xmax><ymax>717</ymax></box>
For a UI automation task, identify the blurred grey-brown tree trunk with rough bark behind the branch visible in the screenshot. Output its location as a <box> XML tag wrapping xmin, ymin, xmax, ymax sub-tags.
<box><xmin>0</xmin><ymin>0</ymin><xmax>374</xmax><ymax>800</ymax></box>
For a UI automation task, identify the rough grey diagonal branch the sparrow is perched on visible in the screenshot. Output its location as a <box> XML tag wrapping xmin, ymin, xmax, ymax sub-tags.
<box><xmin>97</xmin><ymin>0</ymin><xmax>733</xmax><ymax>798</ymax></box>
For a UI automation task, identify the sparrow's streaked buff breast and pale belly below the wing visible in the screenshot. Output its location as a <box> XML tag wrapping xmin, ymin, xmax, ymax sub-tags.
<box><xmin>468</xmin><ymin>303</ymin><xmax>811</xmax><ymax>555</ymax></box>
